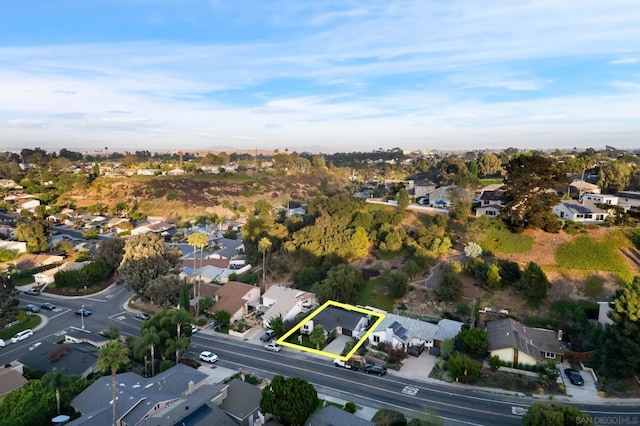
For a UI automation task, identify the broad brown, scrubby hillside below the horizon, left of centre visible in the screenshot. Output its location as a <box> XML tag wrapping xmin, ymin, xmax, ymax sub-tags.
<box><xmin>58</xmin><ymin>173</ymin><xmax>346</xmax><ymax>219</ymax></box>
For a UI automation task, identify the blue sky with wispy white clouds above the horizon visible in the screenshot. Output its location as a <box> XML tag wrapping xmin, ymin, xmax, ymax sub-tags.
<box><xmin>0</xmin><ymin>0</ymin><xmax>640</xmax><ymax>152</ymax></box>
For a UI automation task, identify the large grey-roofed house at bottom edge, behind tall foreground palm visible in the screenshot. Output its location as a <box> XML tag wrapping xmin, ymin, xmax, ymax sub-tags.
<box><xmin>68</xmin><ymin>364</ymin><xmax>209</xmax><ymax>426</ymax></box>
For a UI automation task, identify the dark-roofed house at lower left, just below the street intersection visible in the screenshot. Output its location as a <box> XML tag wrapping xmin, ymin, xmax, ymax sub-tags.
<box><xmin>18</xmin><ymin>340</ymin><xmax>100</xmax><ymax>379</ymax></box>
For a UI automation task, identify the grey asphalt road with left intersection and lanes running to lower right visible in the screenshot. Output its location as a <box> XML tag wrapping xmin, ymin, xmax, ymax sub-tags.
<box><xmin>0</xmin><ymin>286</ymin><xmax>640</xmax><ymax>425</ymax></box>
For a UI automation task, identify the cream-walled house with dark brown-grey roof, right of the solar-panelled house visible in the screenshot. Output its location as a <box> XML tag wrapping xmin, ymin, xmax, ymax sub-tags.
<box><xmin>487</xmin><ymin>318</ymin><xmax>564</xmax><ymax>366</ymax></box>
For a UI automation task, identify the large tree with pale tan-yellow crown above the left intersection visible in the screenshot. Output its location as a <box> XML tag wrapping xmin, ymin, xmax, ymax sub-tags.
<box><xmin>119</xmin><ymin>232</ymin><xmax>180</xmax><ymax>298</ymax></box>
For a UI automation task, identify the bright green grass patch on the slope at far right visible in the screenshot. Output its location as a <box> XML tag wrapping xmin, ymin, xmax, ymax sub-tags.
<box><xmin>556</xmin><ymin>232</ymin><xmax>633</xmax><ymax>282</ymax></box>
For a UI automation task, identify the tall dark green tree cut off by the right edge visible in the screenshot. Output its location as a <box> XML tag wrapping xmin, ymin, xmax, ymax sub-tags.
<box><xmin>598</xmin><ymin>276</ymin><xmax>640</xmax><ymax>378</ymax></box>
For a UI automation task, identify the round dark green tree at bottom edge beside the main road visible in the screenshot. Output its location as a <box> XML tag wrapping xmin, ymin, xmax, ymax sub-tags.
<box><xmin>260</xmin><ymin>375</ymin><xmax>318</xmax><ymax>426</ymax></box>
